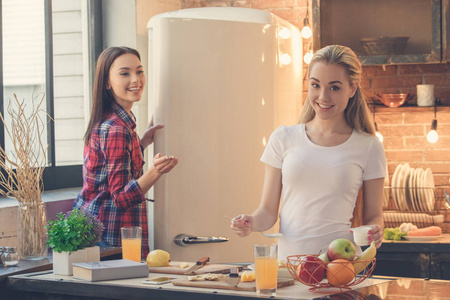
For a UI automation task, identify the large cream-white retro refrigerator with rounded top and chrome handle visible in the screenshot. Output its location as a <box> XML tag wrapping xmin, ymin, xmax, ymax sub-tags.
<box><xmin>147</xmin><ymin>7</ymin><xmax>303</xmax><ymax>263</ymax></box>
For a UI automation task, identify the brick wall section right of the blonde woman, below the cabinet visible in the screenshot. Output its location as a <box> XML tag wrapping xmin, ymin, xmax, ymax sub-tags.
<box><xmin>362</xmin><ymin>63</ymin><xmax>450</xmax><ymax>232</ymax></box>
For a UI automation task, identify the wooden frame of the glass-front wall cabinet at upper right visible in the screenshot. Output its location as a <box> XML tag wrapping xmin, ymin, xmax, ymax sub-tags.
<box><xmin>312</xmin><ymin>0</ymin><xmax>450</xmax><ymax>65</ymax></box>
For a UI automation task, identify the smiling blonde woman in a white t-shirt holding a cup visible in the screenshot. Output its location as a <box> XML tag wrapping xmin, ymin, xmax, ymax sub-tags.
<box><xmin>231</xmin><ymin>45</ymin><xmax>386</xmax><ymax>259</ymax></box>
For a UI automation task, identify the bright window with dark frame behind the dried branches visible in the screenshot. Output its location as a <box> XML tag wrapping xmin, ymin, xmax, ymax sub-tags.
<box><xmin>0</xmin><ymin>0</ymin><xmax>102</xmax><ymax>190</ymax></box>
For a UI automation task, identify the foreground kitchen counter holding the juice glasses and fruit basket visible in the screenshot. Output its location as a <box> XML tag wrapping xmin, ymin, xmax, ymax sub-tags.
<box><xmin>8</xmin><ymin>271</ymin><xmax>450</xmax><ymax>300</ymax></box>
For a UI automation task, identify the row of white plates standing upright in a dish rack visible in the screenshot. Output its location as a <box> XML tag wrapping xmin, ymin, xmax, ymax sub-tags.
<box><xmin>391</xmin><ymin>163</ymin><xmax>435</xmax><ymax>211</ymax></box>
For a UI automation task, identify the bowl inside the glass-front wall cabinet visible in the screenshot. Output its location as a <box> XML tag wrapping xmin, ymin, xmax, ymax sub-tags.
<box><xmin>360</xmin><ymin>36</ymin><xmax>409</xmax><ymax>55</ymax></box>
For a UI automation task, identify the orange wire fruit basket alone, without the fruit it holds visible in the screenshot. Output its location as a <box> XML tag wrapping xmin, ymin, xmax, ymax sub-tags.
<box><xmin>286</xmin><ymin>255</ymin><xmax>376</xmax><ymax>293</ymax></box>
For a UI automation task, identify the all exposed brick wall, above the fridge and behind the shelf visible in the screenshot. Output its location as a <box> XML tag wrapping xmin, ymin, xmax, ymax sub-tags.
<box><xmin>182</xmin><ymin>0</ymin><xmax>450</xmax><ymax>232</ymax></box>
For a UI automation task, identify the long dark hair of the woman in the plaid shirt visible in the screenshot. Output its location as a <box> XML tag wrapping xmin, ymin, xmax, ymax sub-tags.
<box><xmin>84</xmin><ymin>47</ymin><xmax>141</xmax><ymax>145</ymax></box>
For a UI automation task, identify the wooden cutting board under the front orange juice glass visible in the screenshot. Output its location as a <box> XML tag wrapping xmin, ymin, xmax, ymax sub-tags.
<box><xmin>172</xmin><ymin>278</ymin><xmax>295</xmax><ymax>292</ymax></box>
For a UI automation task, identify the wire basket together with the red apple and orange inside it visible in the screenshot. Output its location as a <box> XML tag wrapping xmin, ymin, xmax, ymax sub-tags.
<box><xmin>286</xmin><ymin>255</ymin><xmax>376</xmax><ymax>292</ymax></box>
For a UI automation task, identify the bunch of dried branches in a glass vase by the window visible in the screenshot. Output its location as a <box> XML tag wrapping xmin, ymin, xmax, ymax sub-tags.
<box><xmin>0</xmin><ymin>94</ymin><xmax>51</xmax><ymax>259</ymax></box>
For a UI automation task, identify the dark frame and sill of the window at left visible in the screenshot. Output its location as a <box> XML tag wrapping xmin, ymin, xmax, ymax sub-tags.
<box><xmin>0</xmin><ymin>0</ymin><xmax>103</xmax><ymax>190</ymax></box>
